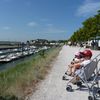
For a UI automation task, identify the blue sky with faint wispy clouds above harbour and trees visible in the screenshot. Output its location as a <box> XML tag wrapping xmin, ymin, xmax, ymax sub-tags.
<box><xmin>0</xmin><ymin>0</ymin><xmax>100</xmax><ymax>41</ymax></box>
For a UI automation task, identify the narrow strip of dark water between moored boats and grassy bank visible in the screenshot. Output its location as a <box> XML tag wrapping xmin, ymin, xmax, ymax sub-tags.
<box><xmin>0</xmin><ymin>54</ymin><xmax>37</xmax><ymax>71</ymax></box>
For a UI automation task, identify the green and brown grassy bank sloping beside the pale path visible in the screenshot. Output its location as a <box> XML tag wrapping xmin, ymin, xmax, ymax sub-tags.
<box><xmin>0</xmin><ymin>48</ymin><xmax>61</xmax><ymax>100</ymax></box>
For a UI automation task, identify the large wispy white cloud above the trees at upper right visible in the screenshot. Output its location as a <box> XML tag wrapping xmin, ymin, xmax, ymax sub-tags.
<box><xmin>77</xmin><ymin>0</ymin><xmax>100</xmax><ymax>16</ymax></box>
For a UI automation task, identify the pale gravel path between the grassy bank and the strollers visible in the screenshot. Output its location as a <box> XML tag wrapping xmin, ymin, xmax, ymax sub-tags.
<box><xmin>30</xmin><ymin>46</ymin><xmax>100</xmax><ymax>100</ymax></box>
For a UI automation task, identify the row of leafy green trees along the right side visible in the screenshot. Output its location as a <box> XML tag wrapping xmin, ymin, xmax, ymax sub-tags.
<box><xmin>69</xmin><ymin>10</ymin><xmax>100</xmax><ymax>42</ymax></box>
